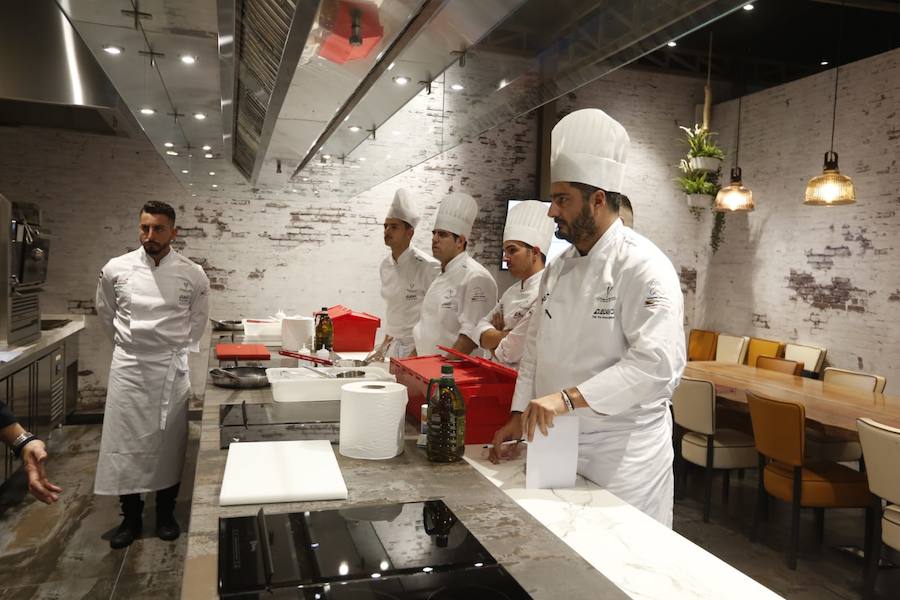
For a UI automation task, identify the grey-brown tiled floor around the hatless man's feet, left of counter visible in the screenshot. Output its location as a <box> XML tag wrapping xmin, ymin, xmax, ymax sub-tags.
<box><xmin>0</xmin><ymin>424</ymin><xmax>199</xmax><ymax>600</ymax></box>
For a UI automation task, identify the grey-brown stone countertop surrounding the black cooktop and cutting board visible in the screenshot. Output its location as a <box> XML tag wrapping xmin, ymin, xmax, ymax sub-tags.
<box><xmin>181</xmin><ymin>336</ymin><xmax>628</xmax><ymax>600</ymax></box>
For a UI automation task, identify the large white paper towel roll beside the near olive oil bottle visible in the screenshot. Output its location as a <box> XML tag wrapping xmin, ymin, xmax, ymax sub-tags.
<box><xmin>340</xmin><ymin>381</ymin><xmax>407</xmax><ymax>460</ymax></box>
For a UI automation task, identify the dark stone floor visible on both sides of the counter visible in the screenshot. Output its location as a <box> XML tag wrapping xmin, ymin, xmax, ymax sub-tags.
<box><xmin>0</xmin><ymin>425</ymin><xmax>900</xmax><ymax>600</ymax></box>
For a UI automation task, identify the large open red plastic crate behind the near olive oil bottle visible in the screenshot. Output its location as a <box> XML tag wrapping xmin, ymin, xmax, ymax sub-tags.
<box><xmin>391</xmin><ymin>346</ymin><xmax>518</xmax><ymax>444</ymax></box>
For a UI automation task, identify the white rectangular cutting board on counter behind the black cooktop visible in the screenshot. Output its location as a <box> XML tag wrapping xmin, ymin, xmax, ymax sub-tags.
<box><xmin>219</xmin><ymin>440</ymin><xmax>347</xmax><ymax>506</ymax></box>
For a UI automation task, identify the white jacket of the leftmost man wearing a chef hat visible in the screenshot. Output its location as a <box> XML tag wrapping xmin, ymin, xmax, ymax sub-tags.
<box><xmin>379</xmin><ymin>246</ymin><xmax>441</xmax><ymax>358</ymax></box>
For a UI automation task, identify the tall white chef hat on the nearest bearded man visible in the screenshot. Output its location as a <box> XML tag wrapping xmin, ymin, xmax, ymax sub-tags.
<box><xmin>550</xmin><ymin>108</ymin><xmax>629</xmax><ymax>192</ymax></box>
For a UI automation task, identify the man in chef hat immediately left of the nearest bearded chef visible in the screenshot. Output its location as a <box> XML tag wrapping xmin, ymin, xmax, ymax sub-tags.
<box><xmin>475</xmin><ymin>200</ymin><xmax>556</xmax><ymax>369</ymax></box>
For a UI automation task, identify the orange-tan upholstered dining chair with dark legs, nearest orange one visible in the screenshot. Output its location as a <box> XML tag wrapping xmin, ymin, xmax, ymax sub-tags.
<box><xmin>747</xmin><ymin>392</ymin><xmax>873</xmax><ymax>569</ymax></box>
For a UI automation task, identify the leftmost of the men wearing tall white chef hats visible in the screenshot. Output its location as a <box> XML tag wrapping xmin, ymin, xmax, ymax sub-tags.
<box><xmin>374</xmin><ymin>188</ymin><xmax>441</xmax><ymax>360</ymax></box>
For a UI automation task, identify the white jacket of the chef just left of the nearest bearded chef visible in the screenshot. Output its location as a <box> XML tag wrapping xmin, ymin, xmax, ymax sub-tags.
<box><xmin>473</xmin><ymin>271</ymin><xmax>542</xmax><ymax>369</ymax></box>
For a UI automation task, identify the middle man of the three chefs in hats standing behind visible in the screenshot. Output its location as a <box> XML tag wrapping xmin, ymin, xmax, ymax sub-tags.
<box><xmin>413</xmin><ymin>192</ymin><xmax>497</xmax><ymax>356</ymax></box>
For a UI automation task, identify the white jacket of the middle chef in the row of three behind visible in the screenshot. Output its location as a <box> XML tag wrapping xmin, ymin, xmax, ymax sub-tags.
<box><xmin>413</xmin><ymin>252</ymin><xmax>497</xmax><ymax>356</ymax></box>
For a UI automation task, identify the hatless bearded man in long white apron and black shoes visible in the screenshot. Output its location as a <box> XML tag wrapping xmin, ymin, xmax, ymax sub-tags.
<box><xmin>94</xmin><ymin>202</ymin><xmax>209</xmax><ymax>548</ymax></box>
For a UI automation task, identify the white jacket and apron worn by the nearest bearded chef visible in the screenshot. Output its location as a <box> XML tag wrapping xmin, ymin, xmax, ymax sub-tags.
<box><xmin>512</xmin><ymin>220</ymin><xmax>685</xmax><ymax>526</ymax></box>
